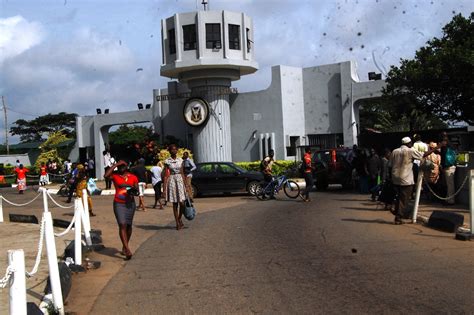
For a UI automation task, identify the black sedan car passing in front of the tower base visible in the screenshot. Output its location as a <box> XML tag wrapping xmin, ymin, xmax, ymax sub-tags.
<box><xmin>192</xmin><ymin>162</ymin><xmax>263</xmax><ymax>197</ymax></box>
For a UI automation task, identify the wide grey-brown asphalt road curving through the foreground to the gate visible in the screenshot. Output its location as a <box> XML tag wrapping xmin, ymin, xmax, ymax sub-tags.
<box><xmin>92</xmin><ymin>192</ymin><xmax>474</xmax><ymax>314</ymax></box>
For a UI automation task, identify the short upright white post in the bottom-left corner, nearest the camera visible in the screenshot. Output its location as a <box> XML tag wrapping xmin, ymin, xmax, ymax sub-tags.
<box><xmin>8</xmin><ymin>249</ymin><xmax>26</xmax><ymax>315</ymax></box>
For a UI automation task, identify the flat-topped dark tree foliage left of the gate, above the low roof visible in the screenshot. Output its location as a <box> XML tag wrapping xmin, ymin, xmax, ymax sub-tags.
<box><xmin>10</xmin><ymin>112</ymin><xmax>77</xmax><ymax>142</ymax></box>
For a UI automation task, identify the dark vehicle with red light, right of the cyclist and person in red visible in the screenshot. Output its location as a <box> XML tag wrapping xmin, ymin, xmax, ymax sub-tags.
<box><xmin>312</xmin><ymin>148</ymin><xmax>352</xmax><ymax>190</ymax></box>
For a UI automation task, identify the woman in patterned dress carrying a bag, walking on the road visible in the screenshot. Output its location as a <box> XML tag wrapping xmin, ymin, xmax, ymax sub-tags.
<box><xmin>162</xmin><ymin>144</ymin><xmax>186</xmax><ymax>230</ymax></box>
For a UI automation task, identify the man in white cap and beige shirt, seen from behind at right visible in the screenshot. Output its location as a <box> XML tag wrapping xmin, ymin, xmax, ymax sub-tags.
<box><xmin>390</xmin><ymin>137</ymin><xmax>433</xmax><ymax>224</ymax></box>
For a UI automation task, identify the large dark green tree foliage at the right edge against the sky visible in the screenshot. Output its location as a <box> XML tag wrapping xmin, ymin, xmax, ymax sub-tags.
<box><xmin>384</xmin><ymin>12</ymin><xmax>474</xmax><ymax>124</ymax></box>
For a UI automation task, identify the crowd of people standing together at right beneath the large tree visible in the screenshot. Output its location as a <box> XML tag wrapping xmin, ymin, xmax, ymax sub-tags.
<box><xmin>346</xmin><ymin>133</ymin><xmax>456</xmax><ymax>224</ymax></box>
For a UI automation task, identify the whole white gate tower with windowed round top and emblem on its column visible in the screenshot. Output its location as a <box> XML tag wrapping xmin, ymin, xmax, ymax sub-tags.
<box><xmin>161</xmin><ymin>6</ymin><xmax>258</xmax><ymax>162</ymax></box>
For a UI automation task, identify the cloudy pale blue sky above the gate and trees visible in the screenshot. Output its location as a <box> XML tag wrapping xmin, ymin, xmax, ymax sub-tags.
<box><xmin>0</xmin><ymin>0</ymin><xmax>474</xmax><ymax>143</ymax></box>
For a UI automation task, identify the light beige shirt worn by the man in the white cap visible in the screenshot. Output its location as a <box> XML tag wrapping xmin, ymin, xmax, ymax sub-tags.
<box><xmin>390</xmin><ymin>145</ymin><xmax>423</xmax><ymax>186</ymax></box>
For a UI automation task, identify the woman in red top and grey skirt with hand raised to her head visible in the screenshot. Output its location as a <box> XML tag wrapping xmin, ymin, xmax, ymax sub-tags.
<box><xmin>104</xmin><ymin>160</ymin><xmax>138</xmax><ymax>260</ymax></box>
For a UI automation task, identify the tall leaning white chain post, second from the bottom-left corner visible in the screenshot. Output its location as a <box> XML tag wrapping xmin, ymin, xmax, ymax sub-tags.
<box><xmin>43</xmin><ymin>211</ymin><xmax>64</xmax><ymax>315</ymax></box>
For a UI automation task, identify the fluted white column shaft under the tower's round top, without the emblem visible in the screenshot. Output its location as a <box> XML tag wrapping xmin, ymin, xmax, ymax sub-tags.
<box><xmin>189</xmin><ymin>79</ymin><xmax>232</xmax><ymax>162</ymax></box>
